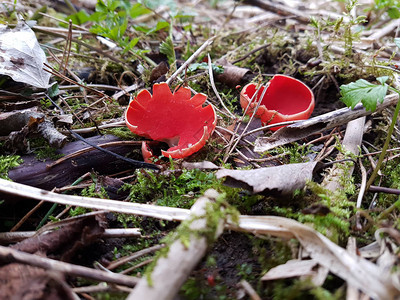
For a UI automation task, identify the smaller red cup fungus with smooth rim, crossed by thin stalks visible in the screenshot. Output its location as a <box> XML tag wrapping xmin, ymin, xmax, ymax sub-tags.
<box><xmin>240</xmin><ymin>75</ymin><xmax>315</xmax><ymax>130</ymax></box>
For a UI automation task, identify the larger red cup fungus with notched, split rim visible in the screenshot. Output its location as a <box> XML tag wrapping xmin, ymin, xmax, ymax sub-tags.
<box><xmin>125</xmin><ymin>83</ymin><xmax>217</xmax><ymax>159</ymax></box>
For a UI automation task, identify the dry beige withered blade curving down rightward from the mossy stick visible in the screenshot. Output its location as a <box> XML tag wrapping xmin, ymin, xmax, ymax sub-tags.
<box><xmin>239</xmin><ymin>215</ymin><xmax>400</xmax><ymax>299</ymax></box>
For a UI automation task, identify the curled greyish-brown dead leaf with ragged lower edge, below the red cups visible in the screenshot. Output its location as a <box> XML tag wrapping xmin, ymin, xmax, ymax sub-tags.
<box><xmin>216</xmin><ymin>162</ymin><xmax>320</xmax><ymax>196</ymax></box>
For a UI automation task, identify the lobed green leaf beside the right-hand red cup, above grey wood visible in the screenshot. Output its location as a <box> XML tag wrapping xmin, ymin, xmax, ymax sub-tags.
<box><xmin>340</xmin><ymin>77</ymin><xmax>388</xmax><ymax>111</ymax></box>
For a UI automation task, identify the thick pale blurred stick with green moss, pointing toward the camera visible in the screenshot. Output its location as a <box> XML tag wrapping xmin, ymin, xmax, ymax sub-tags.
<box><xmin>127</xmin><ymin>190</ymin><xmax>224</xmax><ymax>300</ymax></box>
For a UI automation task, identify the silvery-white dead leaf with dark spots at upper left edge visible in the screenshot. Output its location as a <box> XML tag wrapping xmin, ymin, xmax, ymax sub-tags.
<box><xmin>0</xmin><ymin>23</ymin><xmax>50</xmax><ymax>89</ymax></box>
